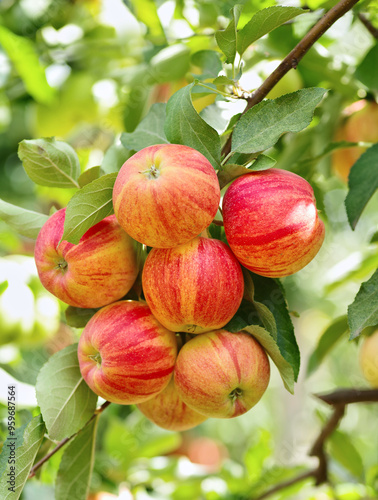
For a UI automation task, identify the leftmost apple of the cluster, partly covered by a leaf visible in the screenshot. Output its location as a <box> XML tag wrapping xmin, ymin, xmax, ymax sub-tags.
<box><xmin>34</xmin><ymin>208</ymin><xmax>138</xmax><ymax>308</ymax></box>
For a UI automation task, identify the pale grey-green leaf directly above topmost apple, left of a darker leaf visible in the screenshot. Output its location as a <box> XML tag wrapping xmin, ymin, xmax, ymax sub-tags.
<box><xmin>121</xmin><ymin>102</ymin><xmax>168</xmax><ymax>151</ymax></box>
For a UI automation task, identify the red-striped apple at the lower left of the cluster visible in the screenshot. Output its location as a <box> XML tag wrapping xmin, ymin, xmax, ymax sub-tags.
<box><xmin>78</xmin><ymin>300</ymin><xmax>177</xmax><ymax>404</ymax></box>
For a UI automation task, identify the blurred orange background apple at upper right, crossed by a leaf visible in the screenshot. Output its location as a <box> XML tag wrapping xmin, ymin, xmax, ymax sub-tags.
<box><xmin>332</xmin><ymin>100</ymin><xmax>378</xmax><ymax>182</ymax></box>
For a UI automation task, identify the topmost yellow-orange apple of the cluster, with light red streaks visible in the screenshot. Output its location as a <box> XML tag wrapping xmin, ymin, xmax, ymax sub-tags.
<box><xmin>113</xmin><ymin>144</ymin><xmax>220</xmax><ymax>248</ymax></box>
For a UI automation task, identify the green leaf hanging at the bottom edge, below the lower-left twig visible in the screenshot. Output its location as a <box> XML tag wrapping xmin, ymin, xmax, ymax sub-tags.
<box><xmin>55</xmin><ymin>416</ymin><xmax>98</xmax><ymax>500</ymax></box>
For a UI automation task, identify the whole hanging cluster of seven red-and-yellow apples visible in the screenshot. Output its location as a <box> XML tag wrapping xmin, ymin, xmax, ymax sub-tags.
<box><xmin>35</xmin><ymin>144</ymin><xmax>324</xmax><ymax>430</ymax></box>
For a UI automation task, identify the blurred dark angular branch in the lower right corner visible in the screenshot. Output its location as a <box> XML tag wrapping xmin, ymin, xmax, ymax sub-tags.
<box><xmin>253</xmin><ymin>388</ymin><xmax>378</xmax><ymax>500</ymax></box>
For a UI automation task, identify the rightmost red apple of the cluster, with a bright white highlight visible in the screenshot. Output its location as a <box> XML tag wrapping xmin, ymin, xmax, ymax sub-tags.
<box><xmin>223</xmin><ymin>168</ymin><xmax>325</xmax><ymax>278</ymax></box>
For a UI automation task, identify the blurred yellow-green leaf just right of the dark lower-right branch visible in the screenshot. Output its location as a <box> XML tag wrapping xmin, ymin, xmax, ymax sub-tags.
<box><xmin>327</xmin><ymin>430</ymin><xmax>364</xmax><ymax>479</ymax></box>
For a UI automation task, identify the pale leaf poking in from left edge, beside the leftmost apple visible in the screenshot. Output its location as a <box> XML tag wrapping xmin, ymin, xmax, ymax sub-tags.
<box><xmin>0</xmin><ymin>200</ymin><xmax>48</xmax><ymax>239</ymax></box>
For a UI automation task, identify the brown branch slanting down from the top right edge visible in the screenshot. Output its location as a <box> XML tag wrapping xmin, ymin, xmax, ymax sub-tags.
<box><xmin>222</xmin><ymin>0</ymin><xmax>359</xmax><ymax>156</ymax></box>
